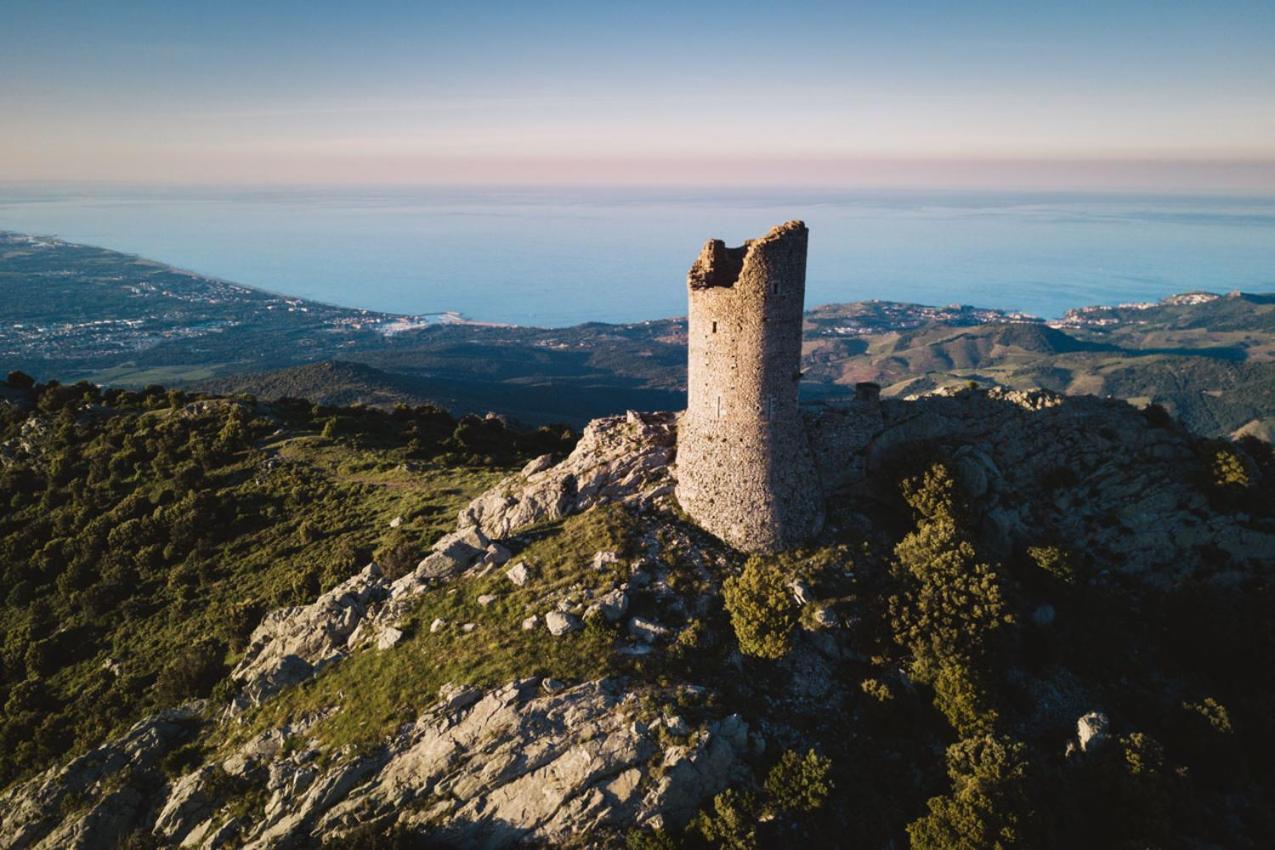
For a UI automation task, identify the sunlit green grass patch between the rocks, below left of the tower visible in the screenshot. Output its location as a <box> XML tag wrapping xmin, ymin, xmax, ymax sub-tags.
<box><xmin>232</xmin><ymin>507</ymin><xmax>635</xmax><ymax>751</ymax></box>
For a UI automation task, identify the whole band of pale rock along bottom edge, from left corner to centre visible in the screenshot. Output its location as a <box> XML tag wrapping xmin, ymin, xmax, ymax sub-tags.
<box><xmin>19</xmin><ymin>679</ymin><xmax>748</xmax><ymax>850</ymax></box>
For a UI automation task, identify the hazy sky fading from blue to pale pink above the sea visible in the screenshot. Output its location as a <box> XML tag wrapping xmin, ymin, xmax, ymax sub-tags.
<box><xmin>0</xmin><ymin>0</ymin><xmax>1275</xmax><ymax>191</ymax></box>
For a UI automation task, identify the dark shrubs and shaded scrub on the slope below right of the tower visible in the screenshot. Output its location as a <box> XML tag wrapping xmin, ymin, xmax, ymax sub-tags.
<box><xmin>708</xmin><ymin>458</ymin><xmax>1275</xmax><ymax>850</ymax></box>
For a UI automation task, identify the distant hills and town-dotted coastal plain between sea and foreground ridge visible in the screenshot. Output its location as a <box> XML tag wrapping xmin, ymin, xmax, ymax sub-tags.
<box><xmin>0</xmin><ymin>233</ymin><xmax>1275</xmax><ymax>436</ymax></box>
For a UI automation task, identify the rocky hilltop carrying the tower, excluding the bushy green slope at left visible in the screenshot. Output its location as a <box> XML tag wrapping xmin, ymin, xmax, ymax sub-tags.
<box><xmin>0</xmin><ymin>389</ymin><xmax>1275</xmax><ymax>850</ymax></box>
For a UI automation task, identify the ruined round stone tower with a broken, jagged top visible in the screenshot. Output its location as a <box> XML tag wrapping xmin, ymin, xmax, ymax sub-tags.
<box><xmin>677</xmin><ymin>222</ymin><xmax>824</xmax><ymax>552</ymax></box>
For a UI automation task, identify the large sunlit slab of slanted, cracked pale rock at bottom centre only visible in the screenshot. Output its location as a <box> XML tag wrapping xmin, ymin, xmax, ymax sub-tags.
<box><xmin>314</xmin><ymin>679</ymin><xmax>747</xmax><ymax>847</ymax></box>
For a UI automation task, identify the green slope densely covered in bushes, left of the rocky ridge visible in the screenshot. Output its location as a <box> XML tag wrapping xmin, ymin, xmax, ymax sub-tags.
<box><xmin>0</xmin><ymin>373</ymin><xmax>571</xmax><ymax>785</ymax></box>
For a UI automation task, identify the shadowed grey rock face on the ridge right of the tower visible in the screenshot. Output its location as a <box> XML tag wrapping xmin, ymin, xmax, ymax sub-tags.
<box><xmin>807</xmin><ymin>387</ymin><xmax>1275</xmax><ymax>585</ymax></box>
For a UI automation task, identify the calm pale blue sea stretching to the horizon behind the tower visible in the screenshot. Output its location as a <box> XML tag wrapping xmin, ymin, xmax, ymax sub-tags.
<box><xmin>0</xmin><ymin>184</ymin><xmax>1275</xmax><ymax>326</ymax></box>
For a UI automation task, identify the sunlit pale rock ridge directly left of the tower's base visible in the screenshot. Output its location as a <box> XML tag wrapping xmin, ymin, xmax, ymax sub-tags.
<box><xmin>458</xmin><ymin>413</ymin><xmax>674</xmax><ymax>539</ymax></box>
